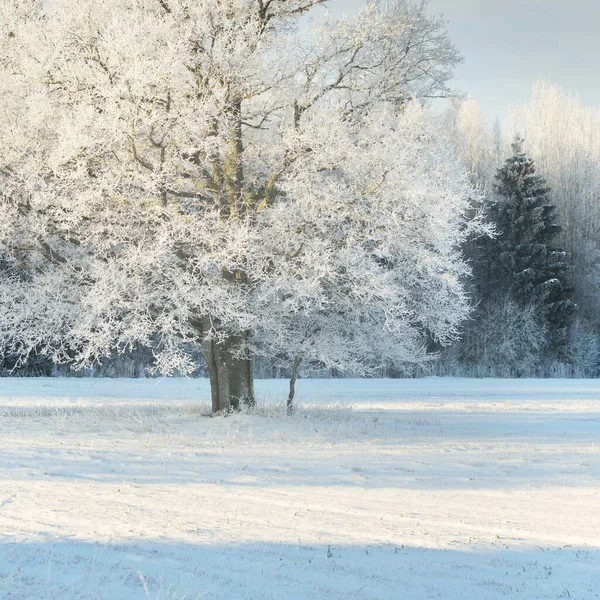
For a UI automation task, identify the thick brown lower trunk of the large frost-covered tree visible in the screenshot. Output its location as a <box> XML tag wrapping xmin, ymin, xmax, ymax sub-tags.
<box><xmin>202</xmin><ymin>316</ymin><xmax>256</xmax><ymax>414</ymax></box>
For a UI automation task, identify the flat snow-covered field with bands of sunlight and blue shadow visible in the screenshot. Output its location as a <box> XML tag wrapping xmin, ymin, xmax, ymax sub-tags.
<box><xmin>0</xmin><ymin>378</ymin><xmax>600</xmax><ymax>600</ymax></box>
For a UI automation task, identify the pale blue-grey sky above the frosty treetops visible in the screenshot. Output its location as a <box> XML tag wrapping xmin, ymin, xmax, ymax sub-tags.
<box><xmin>330</xmin><ymin>0</ymin><xmax>600</xmax><ymax>121</ymax></box>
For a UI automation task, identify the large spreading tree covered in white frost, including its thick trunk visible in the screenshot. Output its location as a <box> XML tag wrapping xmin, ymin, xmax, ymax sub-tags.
<box><xmin>0</xmin><ymin>0</ymin><xmax>478</xmax><ymax>412</ymax></box>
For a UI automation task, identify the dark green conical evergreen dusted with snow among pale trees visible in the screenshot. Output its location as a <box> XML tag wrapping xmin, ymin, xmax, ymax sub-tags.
<box><xmin>475</xmin><ymin>138</ymin><xmax>576</xmax><ymax>351</ymax></box>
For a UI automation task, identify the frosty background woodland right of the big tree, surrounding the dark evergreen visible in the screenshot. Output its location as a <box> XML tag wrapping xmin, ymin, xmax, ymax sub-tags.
<box><xmin>433</xmin><ymin>80</ymin><xmax>600</xmax><ymax>377</ymax></box>
